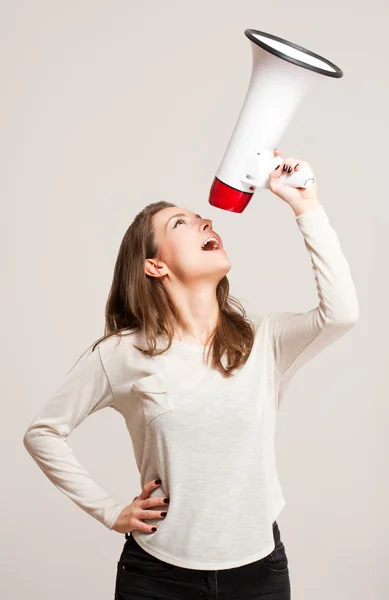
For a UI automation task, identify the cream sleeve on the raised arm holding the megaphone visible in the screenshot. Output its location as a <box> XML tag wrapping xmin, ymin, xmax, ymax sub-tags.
<box><xmin>266</xmin><ymin>204</ymin><xmax>359</xmax><ymax>401</ymax></box>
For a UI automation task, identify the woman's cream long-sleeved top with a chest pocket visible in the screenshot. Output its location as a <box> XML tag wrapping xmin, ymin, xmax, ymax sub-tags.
<box><xmin>23</xmin><ymin>204</ymin><xmax>359</xmax><ymax>570</ymax></box>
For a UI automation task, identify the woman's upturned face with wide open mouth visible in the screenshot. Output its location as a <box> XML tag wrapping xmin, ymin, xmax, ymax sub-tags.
<box><xmin>145</xmin><ymin>206</ymin><xmax>231</xmax><ymax>285</ymax></box>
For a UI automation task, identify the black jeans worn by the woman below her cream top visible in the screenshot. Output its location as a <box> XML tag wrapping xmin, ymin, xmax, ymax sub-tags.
<box><xmin>115</xmin><ymin>521</ymin><xmax>291</xmax><ymax>600</ymax></box>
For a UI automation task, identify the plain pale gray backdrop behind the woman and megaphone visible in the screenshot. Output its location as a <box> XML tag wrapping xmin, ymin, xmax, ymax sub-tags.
<box><xmin>0</xmin><ymin>0</ymin><xmax>389</xmax><ymax>600</ymax></box>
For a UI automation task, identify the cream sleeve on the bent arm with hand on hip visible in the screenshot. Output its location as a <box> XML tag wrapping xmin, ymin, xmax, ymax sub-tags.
<box><xmin>23</xmin><ymin>346</ymin><xmax>126</xmax><ymax>529</ymax></box>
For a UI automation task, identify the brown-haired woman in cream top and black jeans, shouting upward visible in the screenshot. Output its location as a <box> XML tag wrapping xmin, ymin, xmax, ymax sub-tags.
<box><xmin>24</xmin><ymin>150</ymin><xmax>359</xmax><ymax>600</ymax></box>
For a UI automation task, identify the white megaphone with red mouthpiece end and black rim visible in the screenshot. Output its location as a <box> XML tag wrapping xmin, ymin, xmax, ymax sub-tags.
<box><xmin>209</xmin><ymin>29</ymin><xmax>343</xmax><ymax>213</ymax></box>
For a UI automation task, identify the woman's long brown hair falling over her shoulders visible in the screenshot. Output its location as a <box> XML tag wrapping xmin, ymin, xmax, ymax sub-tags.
<box><xmin>88</xmin><ymin>201</ymin><xmax>255</xmax><ymax>377</ymax></box>
